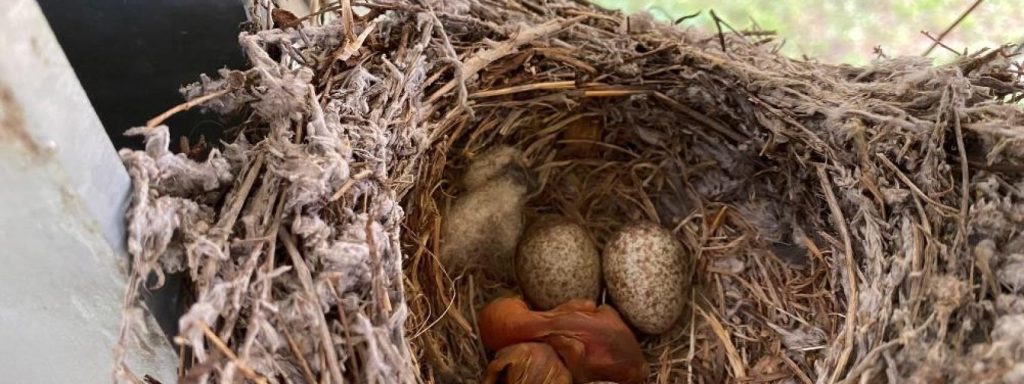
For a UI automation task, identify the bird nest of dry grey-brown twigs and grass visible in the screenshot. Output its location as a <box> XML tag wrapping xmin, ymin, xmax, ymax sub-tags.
<box><xmin>116</xmin><ymin>0</ymin><xmax>1024</xmax><ymax>383</ymax></box>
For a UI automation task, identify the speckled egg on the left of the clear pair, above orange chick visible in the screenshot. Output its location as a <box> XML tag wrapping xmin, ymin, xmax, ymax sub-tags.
<box><xmin>515</xmin><ymin>217</ymin><xmax>601</xmax><ymax>310</ymax></box>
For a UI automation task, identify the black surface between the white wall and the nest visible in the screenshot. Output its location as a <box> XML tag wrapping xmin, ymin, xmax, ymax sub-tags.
<box><xmin>39</xmin><ymin>0</ymin><xmax>247</xmax><ymax>148</ymax></box>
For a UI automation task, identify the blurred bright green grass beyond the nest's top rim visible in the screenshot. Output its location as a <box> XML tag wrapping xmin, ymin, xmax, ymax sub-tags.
<box><xmin>592</xmin><ymin>0</ymin><xmax>1024</xmax><ymax>65</ymax></box>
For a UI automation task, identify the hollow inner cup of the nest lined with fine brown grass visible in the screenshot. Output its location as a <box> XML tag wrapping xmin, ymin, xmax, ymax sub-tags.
<box><xmin>406</xmin><ymin>9</ymin><xmax>846</xmax><ymax>382</ymax></box>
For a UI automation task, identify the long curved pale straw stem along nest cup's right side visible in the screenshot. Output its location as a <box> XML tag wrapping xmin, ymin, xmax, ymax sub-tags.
<box><xmin>818</xmin><ymin>166</ymin><xmax>858</xmax><ymax>383</ymax></box>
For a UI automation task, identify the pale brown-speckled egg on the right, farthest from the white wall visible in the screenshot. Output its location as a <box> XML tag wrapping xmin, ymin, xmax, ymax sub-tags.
<box><xmin>602</xmin><ymin>222</ymin><xmax>691</xmax><ymax>335</ymax></box>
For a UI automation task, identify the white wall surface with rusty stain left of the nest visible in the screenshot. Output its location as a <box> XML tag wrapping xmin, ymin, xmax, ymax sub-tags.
<box><xmin>0</xmin><ymin>0</ymin><xmax>176</xmax><ymax>383</ymax></box>
